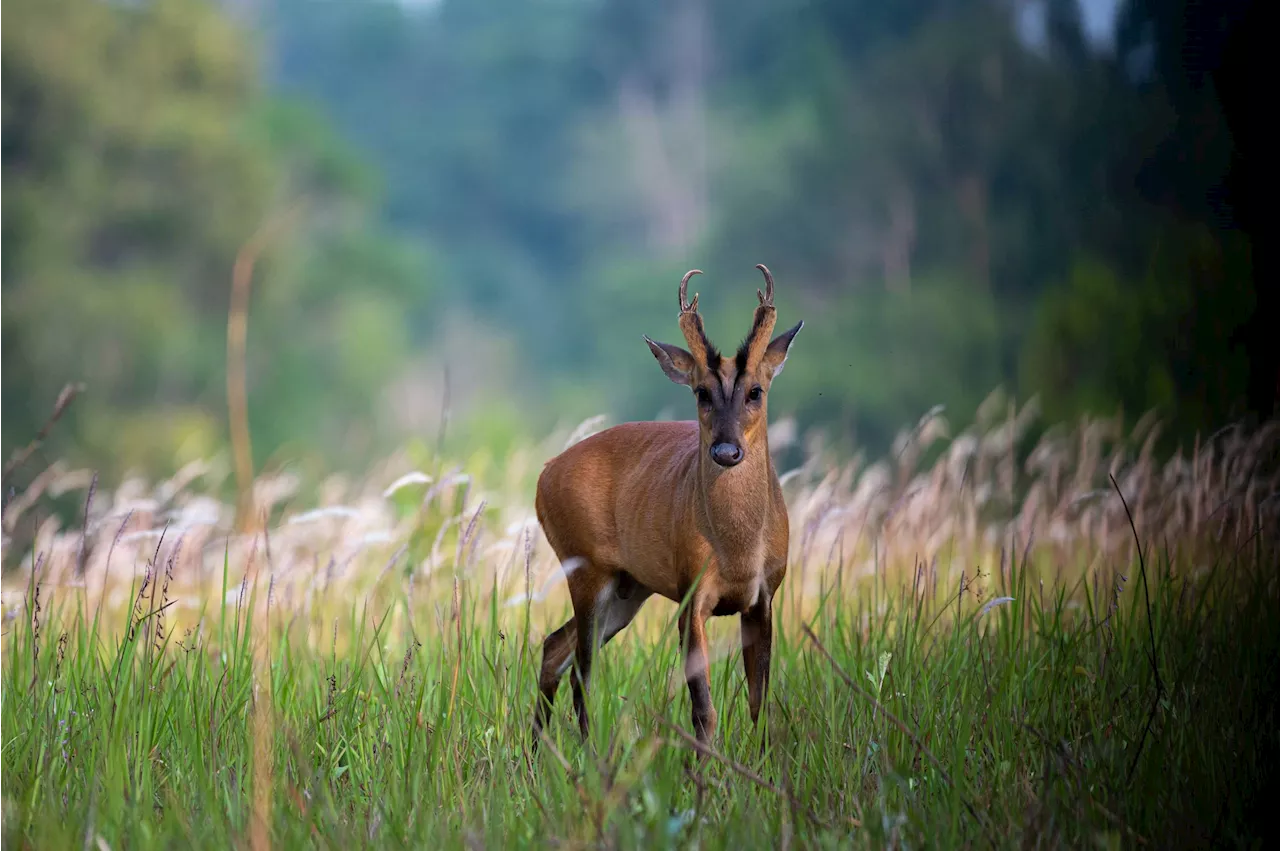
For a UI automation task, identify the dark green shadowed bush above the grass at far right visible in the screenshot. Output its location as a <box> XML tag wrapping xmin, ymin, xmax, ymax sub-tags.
<box><xmin>1023</xmin><ymin>227</ymin><xmax>1252</xmax><ymax>434</ymax></box>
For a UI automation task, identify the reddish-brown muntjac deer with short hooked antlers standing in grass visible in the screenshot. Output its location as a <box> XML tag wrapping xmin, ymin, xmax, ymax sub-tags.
<box><xmin>534</xmin><ymin>265</ymin><xmax>804</xmax><ymax>747</ymax></box>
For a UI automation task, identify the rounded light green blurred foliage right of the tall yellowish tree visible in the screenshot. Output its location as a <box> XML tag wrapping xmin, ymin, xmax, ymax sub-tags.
<box><xmin>248</xmin><ymin>212</ymin><xmax>433</xmax><ymax>463</ymax></box>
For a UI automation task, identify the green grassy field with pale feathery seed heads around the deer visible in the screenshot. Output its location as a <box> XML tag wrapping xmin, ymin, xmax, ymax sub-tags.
<box><xmin>0</xmin><ymin>401</ymin><xmax>1280</xmax><ymax>848</ymax></box>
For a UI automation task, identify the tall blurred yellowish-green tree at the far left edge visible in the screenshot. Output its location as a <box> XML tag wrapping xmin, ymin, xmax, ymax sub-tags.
<box><xmin>0</xmin><ymin>0</ymin><xmax>271</xmax><ymax>470</ymax></box>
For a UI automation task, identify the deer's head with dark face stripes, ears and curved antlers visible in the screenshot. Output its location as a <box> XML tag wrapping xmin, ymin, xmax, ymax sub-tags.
<box><xmin>644</xmin><ymin>264</ymin><xmax>804</xmax><ymax>467</ymax></box>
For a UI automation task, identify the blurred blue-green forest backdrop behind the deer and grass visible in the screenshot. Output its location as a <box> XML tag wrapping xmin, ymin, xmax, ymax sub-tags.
<box><xmin>0</xmin><ymin>0</ymin><xmax>1276</xmax><ymax>476</ymax></box>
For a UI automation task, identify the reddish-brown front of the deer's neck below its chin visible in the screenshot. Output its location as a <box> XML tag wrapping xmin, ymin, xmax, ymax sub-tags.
<box><xmin>698</xmin><ymin>438</ymin><xmax>774</xmax><ymax>561</ymax></box>
